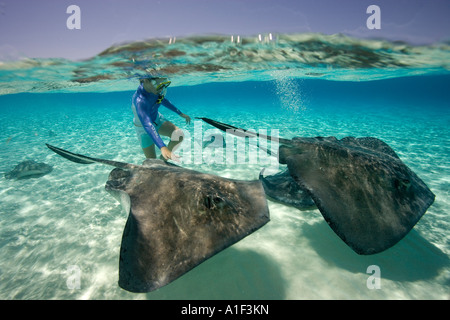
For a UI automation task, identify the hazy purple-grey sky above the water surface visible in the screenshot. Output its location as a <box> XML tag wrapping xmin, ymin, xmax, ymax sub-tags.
<box><xmin>0</xmin><ymin>0</ymin><xmax>450</xmax><ymax>61</ymax></box>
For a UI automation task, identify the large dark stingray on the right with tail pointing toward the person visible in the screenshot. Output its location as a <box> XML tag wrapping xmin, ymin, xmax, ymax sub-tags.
<box><xmin>200</xmin><ymin>118</ymin><xmax>435</xmax><ymax>254</ymax></box>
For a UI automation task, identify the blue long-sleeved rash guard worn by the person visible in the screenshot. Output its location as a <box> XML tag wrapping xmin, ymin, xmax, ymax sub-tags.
<box><xmin>132</xmin><ymin>84</ymin><xmax>181</xmax><ymax>149</ymax></box>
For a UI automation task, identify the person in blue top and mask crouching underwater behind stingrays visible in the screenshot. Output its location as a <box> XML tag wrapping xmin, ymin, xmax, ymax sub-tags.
<box><xmin>131</xmin><ymin>76</ymin><xmax>191</xmax><ymax>160</ymax></box>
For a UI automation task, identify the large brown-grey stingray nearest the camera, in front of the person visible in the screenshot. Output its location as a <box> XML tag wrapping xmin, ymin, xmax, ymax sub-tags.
<box><xmin>47</xmin><ymin>144</ymin><xmax>269</xmax><ymax>292</ymax></box>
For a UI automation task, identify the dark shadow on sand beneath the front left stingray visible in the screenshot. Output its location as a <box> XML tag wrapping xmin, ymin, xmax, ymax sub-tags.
<box><xmin>142</xmin><ymin>246</ymin><xmax>288</xmax><ymax>300</ymax></box>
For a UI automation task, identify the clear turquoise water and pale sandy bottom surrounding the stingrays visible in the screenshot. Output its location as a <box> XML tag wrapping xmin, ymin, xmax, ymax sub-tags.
<box><xmin>0</xmin><ymin>38</ymin><xmax>450</xmax><ymax>299</ymax></box>
